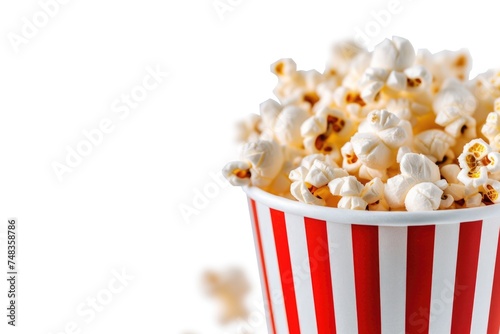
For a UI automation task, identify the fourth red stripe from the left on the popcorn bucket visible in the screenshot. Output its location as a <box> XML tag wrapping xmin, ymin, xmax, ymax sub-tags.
<box><xmin>351</xmin><ymin>225</ymin><xmax>382</xmax><ymax>334</ymax></box>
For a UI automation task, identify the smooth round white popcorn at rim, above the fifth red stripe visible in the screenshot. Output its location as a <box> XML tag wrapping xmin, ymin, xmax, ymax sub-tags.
<box><xmin>405</xmin><ymin>182</ymin><xmax>443</xmax><ymax>211</ymax></box>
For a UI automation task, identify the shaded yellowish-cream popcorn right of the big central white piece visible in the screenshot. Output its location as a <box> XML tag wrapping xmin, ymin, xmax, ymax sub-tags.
<box><xmin>413</xmin><ymin>129</ymin><xmax>455</xmax><ymax>163</ymax></box>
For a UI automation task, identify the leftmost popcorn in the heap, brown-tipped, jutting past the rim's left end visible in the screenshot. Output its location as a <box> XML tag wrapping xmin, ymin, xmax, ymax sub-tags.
<box><xmin>222</xmin><ymin>140</ymin><xmax>284</xmax><ymax>188</ymax></box>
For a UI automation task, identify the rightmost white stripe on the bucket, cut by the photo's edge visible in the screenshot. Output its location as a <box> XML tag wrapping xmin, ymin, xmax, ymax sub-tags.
<box><xmin>471</xmin><ymin>219</ymin><xmax>500</xmax><ymax>333</ymax></box>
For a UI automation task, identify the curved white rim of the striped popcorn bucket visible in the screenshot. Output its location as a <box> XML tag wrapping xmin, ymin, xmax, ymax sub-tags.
<box><xmin>242</xmin><ymin>186</ymin><xmax>500</xmax><ymax>227</ymax></box>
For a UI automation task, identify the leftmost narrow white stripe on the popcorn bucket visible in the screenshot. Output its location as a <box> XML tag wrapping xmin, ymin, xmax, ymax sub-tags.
<box><xmin>257</xmin><ymin>203</ymin><xmax>288</xmax><ymax>334</ymax></box>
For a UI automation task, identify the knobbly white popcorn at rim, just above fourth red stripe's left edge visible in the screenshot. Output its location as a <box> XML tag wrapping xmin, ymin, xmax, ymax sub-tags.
<box><xmin>328</xmin><ymin>175</ymin><xmax>368</xmax><ymax>210</ymax></box>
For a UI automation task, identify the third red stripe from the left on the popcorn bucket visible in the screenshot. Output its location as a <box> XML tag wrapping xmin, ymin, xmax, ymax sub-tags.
<box><xmin>304</xmin><ymin>217</ymin><xmax>337</xmax><ymax>334</ymax></box>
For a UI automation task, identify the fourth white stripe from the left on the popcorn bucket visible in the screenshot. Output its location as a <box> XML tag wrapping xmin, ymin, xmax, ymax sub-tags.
<box><xmin>378</xmin><ymin>226</ymin><xmax>408</xmax><ymax>334</ymax></box>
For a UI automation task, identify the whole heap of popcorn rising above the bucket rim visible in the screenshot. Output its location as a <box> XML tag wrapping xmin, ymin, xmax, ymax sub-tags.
<box><xmin>223</xmin><ymin>36</ymin><xmax>500</xmax><ymax>211</ymax></box>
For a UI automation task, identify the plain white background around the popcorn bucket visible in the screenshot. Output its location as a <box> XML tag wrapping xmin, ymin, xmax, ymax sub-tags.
<box><xmin>0</xmin><ymin>0</ymin><xmax>500</xmax><ymax>334</ymax></box>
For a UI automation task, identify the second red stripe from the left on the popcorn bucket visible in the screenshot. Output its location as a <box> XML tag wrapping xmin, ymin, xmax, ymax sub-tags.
<box><xmin>271</xmin><ymin>209</ymin><xmax>300</xmax><ymax>334</ymax></box>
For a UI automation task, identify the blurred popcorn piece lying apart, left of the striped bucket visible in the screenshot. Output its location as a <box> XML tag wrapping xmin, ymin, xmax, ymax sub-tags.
<box><xmin>203</xmin><ymin>268</ymin><xmax>250</xmax><ymax>323</ymax></box>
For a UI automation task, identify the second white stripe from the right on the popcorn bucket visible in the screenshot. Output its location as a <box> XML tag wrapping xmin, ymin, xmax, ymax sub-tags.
<box><xmin>429</xmin><ymin>224</ymin><xmax>460</xmax><ymax>334</ymax></box>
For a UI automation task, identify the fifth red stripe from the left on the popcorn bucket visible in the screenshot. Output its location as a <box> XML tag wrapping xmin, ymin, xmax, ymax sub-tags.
<box><xmin>406</xmin><ymin>225</ymin><xmax>436</xmax><ymax>334</ymax></box>
